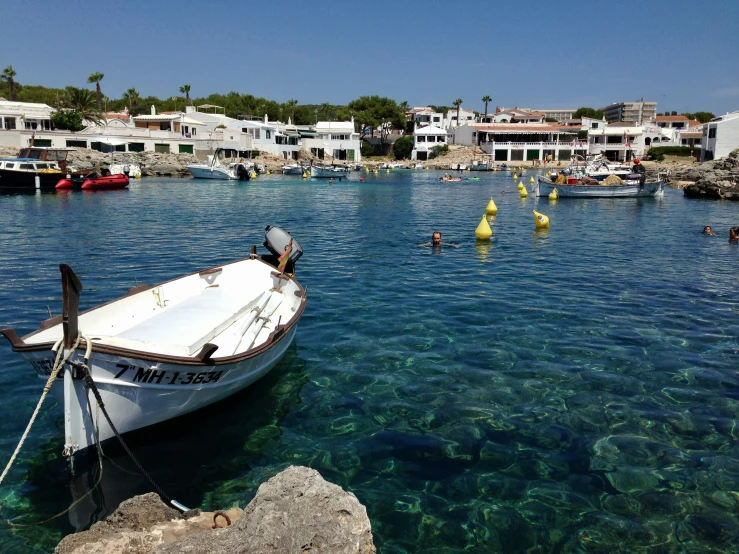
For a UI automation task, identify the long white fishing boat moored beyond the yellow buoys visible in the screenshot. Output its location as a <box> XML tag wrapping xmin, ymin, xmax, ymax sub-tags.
<box><xmin>533</xmin><ymin>174</ymin><xmax>665</xmax><ymax>198</ymax></box>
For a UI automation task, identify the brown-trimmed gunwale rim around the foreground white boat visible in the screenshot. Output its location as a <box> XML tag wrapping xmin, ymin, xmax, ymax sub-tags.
<box><xmin>0</xmin><ymin>256</ymin><xmax>307</xmax><ymax>366</ymax></box>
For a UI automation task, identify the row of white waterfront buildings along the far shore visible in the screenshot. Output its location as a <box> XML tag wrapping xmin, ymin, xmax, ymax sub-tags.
<box><xmin>0</xmin><ymin>93</ymin><xmax>739</xmax><ymax>175</ymax></box>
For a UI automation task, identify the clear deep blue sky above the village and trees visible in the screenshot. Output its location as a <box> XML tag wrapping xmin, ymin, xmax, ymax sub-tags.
<box><xmin>0</xmin><ymin>0</ymin><xmax>739</xmax><ymax>115</ymax></box>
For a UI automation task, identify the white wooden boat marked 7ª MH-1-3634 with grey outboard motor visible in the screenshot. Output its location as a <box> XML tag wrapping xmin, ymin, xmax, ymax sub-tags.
<box><xmin>0</xmin><ymin>227</ymin><xmax>306</xmax><ymax>456</ymax></box>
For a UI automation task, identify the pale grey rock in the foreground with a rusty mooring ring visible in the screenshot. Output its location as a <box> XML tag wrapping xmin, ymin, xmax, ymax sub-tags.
<box><xmin>54</xmin><ymin>467</ymin><xmax>375</xmax><ymax>554</ymax></box>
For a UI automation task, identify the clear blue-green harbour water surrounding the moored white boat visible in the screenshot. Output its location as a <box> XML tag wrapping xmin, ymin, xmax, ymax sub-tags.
<box><xmin>0</xmin><ymin>171</ymin><xmax>739</xmax><ymax>553</ymax></box>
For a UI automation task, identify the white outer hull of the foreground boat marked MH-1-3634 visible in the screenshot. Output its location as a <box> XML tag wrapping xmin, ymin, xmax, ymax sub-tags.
<box><xmin>23</xmin><ymin>326</ymin><xmax>297</xmax><ymax>448</ymax></box>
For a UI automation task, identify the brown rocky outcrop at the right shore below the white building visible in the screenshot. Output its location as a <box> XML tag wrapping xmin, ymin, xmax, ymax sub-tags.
<box><xmin>670</xmin><ymin>151</ymin><xmax>739</xmax><ymax>200</ymax></box>
